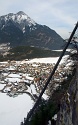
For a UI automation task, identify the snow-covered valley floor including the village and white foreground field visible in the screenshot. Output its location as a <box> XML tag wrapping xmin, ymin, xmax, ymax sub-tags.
<box><xmin>0</xmin><ymin>56</ymin><xmax>74</xmax><ymax>125</ymax></box>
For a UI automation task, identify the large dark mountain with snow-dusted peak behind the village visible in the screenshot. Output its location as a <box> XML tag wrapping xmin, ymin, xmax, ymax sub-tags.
<box><xmin>0</xmin><ymin>11</ymin><xmax>65</xmax><ymax>49</ymax></box>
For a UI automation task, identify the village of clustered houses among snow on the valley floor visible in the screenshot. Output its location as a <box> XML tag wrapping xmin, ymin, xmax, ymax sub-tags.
<box><xmin>0</xmin><ymin>54</ymin><xmax>74</xmax><ymax>101</ymax></box>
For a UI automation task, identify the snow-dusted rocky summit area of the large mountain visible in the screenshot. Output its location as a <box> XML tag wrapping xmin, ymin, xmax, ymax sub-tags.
<box><xmin>0</xmin><ymin>11</ymin><xmax>37</xmax><ymax>33</ymax></box>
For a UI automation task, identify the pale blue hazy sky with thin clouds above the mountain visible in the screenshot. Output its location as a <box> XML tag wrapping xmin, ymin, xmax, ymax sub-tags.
<box><xmin>0</xmin><ymin>0</ymin><xmax>78</xmax><ymax>38</ymax></box>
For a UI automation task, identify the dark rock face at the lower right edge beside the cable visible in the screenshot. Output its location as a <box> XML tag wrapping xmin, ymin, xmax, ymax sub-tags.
<box><xmin>56</xmin><ymin>57</ymin><xmax>78</xmax><ymax>125</ymax></box>
